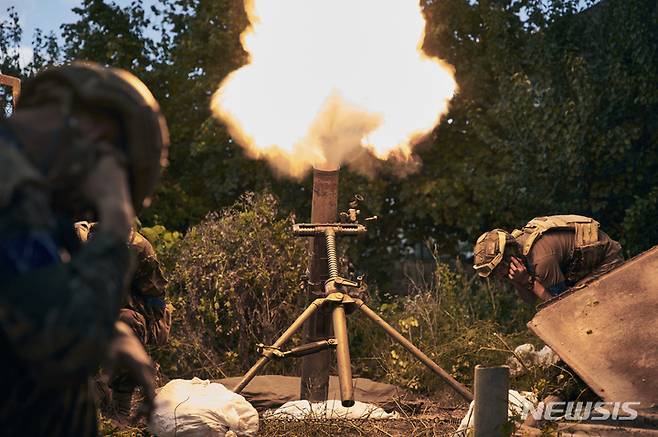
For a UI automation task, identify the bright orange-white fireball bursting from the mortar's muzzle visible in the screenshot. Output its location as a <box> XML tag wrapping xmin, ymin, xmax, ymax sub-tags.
<box><xmin>211</xmin><ymin>0</ymin><xmax>457</xmax><ymax>177</ymax></box>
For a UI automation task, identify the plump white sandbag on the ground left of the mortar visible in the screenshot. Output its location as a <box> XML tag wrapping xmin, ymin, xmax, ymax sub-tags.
<box><xmin>149</xmin><ymin>378</ymin><xmax>258</xmax><ymax>437</ymax></box>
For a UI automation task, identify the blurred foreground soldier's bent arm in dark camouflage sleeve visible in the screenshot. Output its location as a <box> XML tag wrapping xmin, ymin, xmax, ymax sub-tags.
<box><xmin>0</xmin><ymin>231</ymin><xmax>130</xmax><ymax>385</ymax></box>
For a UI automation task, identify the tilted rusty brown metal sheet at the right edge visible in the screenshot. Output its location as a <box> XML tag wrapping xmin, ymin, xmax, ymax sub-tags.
<box><xmin>528</xmin><ymin>246</ymin><xmax>658</xmax><ymax>406</ymax></box>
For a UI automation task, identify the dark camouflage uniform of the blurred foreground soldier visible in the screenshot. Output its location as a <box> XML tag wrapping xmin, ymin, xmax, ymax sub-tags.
<box><xmin>0</xmin><ymin>125</ymin><xmax>130</xmax><ymax>436</ymax></box>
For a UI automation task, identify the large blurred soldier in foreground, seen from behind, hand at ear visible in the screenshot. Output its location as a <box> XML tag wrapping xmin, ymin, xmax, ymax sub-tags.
<box><xmin>0</xmin><ymin>63</ymin><xmax>168</xmax><ymax>436</ymax></box>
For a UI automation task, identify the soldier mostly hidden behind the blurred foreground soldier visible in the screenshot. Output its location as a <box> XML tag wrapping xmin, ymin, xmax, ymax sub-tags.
<box><xmin>74</xmin><ymin>221</ymin><xmax>173</xmax><ymax>418</ymax></box>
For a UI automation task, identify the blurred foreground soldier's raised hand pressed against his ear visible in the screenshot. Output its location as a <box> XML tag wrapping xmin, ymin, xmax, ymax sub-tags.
<box><xmin>83</xmin><ymin>153</ymin><xmax>135</xmax><ymax>241</ymax></box>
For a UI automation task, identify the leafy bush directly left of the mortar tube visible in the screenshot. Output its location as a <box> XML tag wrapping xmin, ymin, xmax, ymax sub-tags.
<box><xmin>156</xmin><ymin>193</ymin><xmax>306</xmax><ymax>378</ymax></box>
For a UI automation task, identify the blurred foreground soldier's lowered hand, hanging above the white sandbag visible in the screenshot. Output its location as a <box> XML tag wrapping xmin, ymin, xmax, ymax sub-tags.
<box><xmin>109</xmin><ymin>321</ymin><xmax>155</xmax><ymax>421</ymax></box>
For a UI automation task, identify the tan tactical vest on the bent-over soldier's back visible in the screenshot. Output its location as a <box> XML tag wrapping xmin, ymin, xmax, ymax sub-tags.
<box><xmin>512</xmin><ymin>214</ymin><xmax>599</xmax><ymax>255</ymax></box>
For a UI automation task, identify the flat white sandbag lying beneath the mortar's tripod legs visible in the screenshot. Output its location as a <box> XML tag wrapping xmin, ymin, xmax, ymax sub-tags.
<box><xmin>263</xmin><ymin>399</ymin><xmax>399</xmax><ymax>419</ymax></box>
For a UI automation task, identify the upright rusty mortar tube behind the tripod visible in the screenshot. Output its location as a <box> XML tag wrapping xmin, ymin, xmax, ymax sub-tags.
<box><xmin>300</xmin><ymin>168</ymin><xmax>339</xmax><ymax>402</ymax></box>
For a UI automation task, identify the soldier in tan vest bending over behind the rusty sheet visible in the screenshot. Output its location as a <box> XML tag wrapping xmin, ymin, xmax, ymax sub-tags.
<box><xmin>473</xmin><ymin>215</ymin><xmax>624</xmax><ymax>303</ymax></box>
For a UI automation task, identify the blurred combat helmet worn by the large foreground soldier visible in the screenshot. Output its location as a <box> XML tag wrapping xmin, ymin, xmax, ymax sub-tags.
<box><xmin>18</xmin><ymin>62</ymin><xmax>169</xmax><ymax>211</ymax></box>
